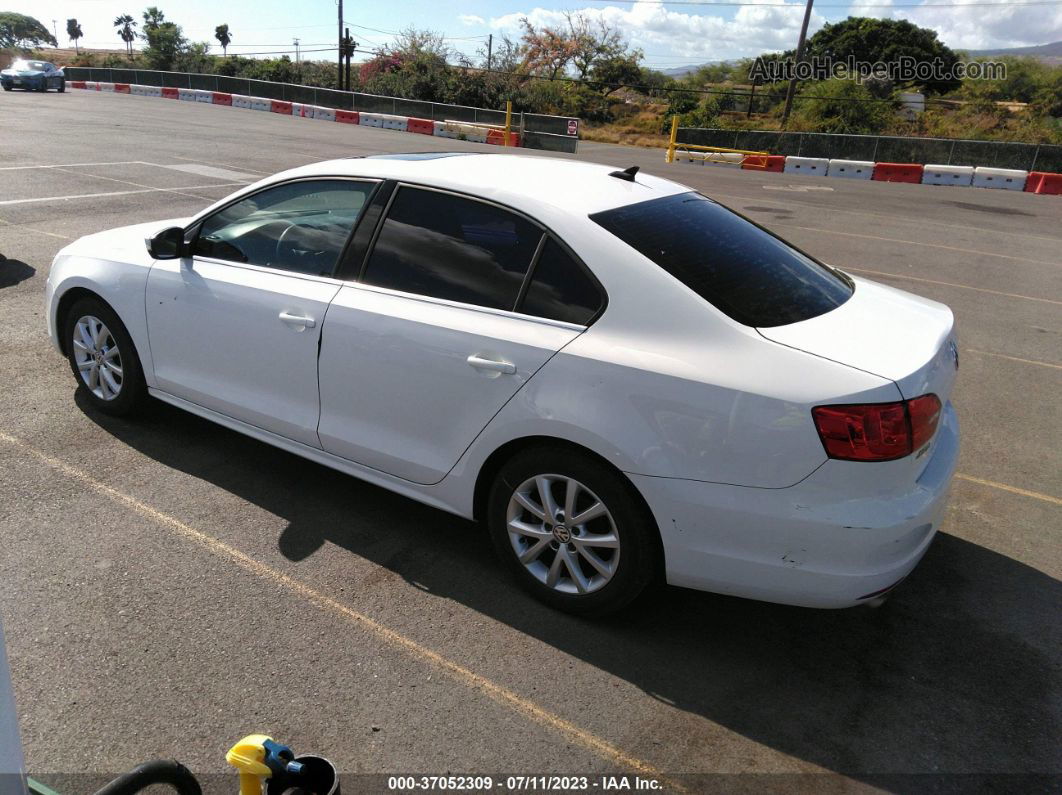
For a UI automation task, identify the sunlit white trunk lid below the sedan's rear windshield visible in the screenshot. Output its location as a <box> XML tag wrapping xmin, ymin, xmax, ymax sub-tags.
<box><xmin>757</xmin><ymin>276</ymin><xmax>959</xmax><ymax>404</ymax></box>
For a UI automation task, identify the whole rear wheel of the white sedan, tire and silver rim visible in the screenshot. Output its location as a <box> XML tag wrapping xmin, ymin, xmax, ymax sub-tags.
<box><xmin>487</xmin><ymin>446</ymin><xmax>658</xmax><ymax>616</ymax></box>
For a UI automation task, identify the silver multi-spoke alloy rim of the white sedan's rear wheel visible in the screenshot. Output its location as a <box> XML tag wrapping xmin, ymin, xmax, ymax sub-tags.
<box><xmin>507</xmin><ymin>474</ymin><xmax>620</xmax><ymax>594</ymax></box>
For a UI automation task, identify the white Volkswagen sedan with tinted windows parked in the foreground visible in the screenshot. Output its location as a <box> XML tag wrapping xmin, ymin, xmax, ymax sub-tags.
<box><xmin>47</xmin><ymin>154</ymin><xmax>959</xmax><ymax>613</ymax></box>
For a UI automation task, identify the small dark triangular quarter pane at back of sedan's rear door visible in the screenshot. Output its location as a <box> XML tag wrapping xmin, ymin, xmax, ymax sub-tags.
<box><xmin>519</xmin><ymin>238</ymin><xmax>604</xmax><ymax>326</ymax></box>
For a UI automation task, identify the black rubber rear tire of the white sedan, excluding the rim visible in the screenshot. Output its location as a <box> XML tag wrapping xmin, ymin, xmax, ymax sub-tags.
<box><xmin>486</xmin><ymin>445</ymin><xmax>660</xmax><ymax>616</ymax></box>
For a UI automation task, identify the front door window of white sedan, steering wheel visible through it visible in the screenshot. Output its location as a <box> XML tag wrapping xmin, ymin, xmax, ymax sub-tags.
<box><xmin>192</xmin><ymin>179</ymin><xmax>376</xmax><ymax>276</ymax></box>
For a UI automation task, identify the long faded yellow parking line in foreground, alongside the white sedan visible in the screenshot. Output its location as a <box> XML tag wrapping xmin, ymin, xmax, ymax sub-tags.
<box><xmin>0</xmin><ymin>431</ymin><xmax>686</xmax><ymax>792</ymax></box>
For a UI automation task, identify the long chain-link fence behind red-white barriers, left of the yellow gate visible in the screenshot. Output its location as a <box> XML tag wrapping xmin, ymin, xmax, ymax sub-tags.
<box><xmin>64</xmin><ymin>66</ymin><xmax>579</xmax><ymax>152</ymax></box>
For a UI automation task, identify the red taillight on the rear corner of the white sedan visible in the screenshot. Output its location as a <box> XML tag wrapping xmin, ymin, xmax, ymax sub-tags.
<box><xmin>811</xmin><ymin>395</ymin><xmax>941</xmax><ymax>461</ymax></box>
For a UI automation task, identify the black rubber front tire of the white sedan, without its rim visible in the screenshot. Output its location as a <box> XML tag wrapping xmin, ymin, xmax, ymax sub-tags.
<box><xmin>59</xmin><ymin>296</ymin><xmax>148</xmax><ymax>416</ymax></box>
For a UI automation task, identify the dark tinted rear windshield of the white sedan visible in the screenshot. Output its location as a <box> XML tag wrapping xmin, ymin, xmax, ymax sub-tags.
<box><xmin>590</xmin><ymin>193</ymin><xmax>853</xmax><ymax>328</ymax></box>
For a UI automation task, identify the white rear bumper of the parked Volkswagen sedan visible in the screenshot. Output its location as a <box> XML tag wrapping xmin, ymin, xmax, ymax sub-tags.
<box><xmin>630</xmin><ymin>403</ymin><xmax>959</xmax><ymax>607</ymax></box>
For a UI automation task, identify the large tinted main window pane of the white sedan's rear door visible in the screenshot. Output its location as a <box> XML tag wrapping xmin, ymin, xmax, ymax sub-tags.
<box><xmin>361</xmin><ymin>186</ymin><xmax>542</xmax><ymax>310</ymax></box>
